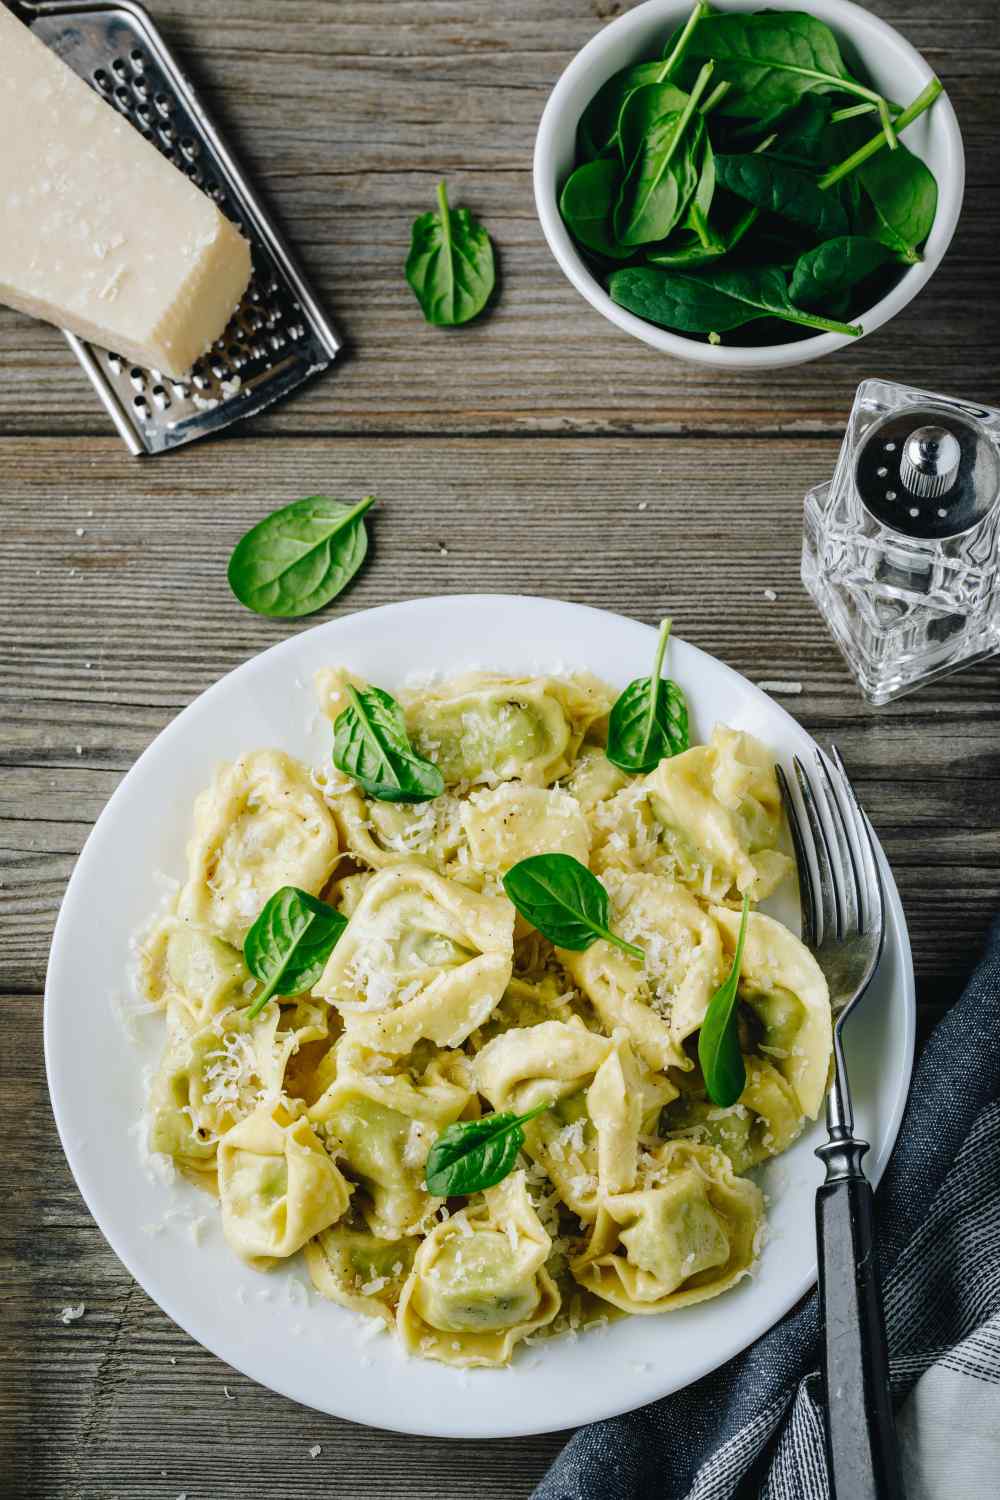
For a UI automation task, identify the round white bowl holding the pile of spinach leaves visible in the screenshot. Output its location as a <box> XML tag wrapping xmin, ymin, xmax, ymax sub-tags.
<box><xmin>534</xmin><ymin>0</ymin><xmax>966</xmax><ymax>369</ymax></box>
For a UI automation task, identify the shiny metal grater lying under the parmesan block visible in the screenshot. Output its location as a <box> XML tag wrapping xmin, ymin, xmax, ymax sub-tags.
<box><xmin>14</xmin><ymin>0</ymin><xmax>340</xmax><ymax>458</ymax></box>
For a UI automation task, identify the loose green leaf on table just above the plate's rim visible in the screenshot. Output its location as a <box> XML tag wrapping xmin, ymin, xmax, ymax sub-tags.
<box><xmin>228</xmin><ymin>495</ymin><xmax>375</xmax><ymax>618</ymax></box>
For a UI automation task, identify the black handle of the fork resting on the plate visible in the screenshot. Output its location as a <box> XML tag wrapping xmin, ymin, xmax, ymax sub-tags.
<box><xmin>816</xmin><ymin>1136</ymin><xmax>904</xmax><ymax>1500</ymax></box>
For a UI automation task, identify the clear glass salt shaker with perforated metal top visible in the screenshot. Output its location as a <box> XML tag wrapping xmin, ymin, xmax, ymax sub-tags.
<box><xmin>802</xmin><ymin>380</ymin><xmax>1000</xmax><ymax>704</ymax></box>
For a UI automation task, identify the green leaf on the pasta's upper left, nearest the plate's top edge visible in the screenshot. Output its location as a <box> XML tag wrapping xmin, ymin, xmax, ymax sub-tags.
<box><xmin>333</xmin><ymin>684</ymin><xmax>444</xmax><ymax>803</ymax></box>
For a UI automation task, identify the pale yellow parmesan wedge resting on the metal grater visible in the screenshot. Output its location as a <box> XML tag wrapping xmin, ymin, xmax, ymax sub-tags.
<box><xmin>0</xmin><ymin>5</ymin><xmax>250</xmax><ymax>378</ymax></box>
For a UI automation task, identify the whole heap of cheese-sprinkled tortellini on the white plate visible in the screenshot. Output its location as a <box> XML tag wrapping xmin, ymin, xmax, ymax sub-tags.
<box><xmin>138</xmin><ymin>668</ymin><xmax>832</xmax><ymax>1367</ymax></box>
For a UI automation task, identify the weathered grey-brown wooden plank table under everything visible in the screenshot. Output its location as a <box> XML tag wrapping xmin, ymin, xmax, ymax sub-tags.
<box><xmin>0</xmin><ymin>0</ymin><xmax>1000</xmax><ymax>1500</ymax></box>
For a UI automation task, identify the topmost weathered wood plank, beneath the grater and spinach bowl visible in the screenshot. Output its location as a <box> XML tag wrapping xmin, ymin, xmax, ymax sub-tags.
<box><xmin>0</xmin><ymin>0</ymin><xmax>1000</xmax><ymax>434</ymax></box>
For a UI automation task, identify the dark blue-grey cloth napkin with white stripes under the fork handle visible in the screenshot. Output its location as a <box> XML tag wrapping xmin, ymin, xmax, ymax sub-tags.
<box><xmin>534</xmin><ymin>920</ymin><xmax>1000</xmax><ymax>1500</ymax></box>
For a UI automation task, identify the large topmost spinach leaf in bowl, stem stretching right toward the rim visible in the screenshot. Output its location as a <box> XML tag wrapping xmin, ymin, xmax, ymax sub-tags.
<box><xmin>671</xmin><ymin>11</ymin><xmax>888</xmax><ymax>129</ymax></box>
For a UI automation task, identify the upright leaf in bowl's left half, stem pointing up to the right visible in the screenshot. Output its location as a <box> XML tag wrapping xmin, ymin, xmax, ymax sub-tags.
<box><xmin>613</xmin><ymin>69</ymin><xmax>709</xmax><ymax>246</ymax></box>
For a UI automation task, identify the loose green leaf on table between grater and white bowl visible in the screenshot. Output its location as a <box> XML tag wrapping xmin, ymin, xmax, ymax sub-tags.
<box><xmin>406</xmin><ymin>183</ymin><xmax>496</xmax><ymax>329</ymax></box>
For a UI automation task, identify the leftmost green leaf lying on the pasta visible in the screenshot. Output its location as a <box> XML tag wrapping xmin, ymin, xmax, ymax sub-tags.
<box><xmin>243</xmin><ymin>885</ymin><xmax>348</xmax><ymax>1020</ymax></box>
